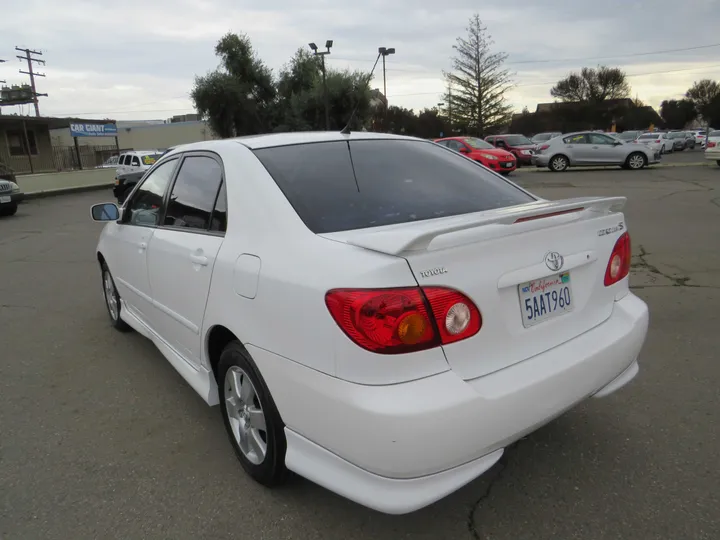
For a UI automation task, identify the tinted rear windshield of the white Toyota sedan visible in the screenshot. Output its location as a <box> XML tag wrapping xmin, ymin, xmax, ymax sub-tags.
<box><xmin>255</xmin><ymin>140</ymin><xmax>535</xmax><ymax>234</ymax></box>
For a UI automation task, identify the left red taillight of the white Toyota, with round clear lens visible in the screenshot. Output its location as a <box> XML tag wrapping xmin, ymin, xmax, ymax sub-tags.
<box><xmin>325</xmin><ymin>287</ymin><xmax>482</xmax><ymax>354</ymax></box>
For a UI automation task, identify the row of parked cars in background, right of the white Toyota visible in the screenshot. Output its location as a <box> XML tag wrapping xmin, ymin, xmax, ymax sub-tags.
<box><xmin>435</xmin><ymin>130</ymin><xmax>720</xmax><ymax>174</ymax></box>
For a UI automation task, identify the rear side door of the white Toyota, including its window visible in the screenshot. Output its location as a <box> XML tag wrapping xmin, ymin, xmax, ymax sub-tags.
<box><xmin>148</xmin><ymin>152</ymin><xmax>227</xmax><ymax>366</ymax></box>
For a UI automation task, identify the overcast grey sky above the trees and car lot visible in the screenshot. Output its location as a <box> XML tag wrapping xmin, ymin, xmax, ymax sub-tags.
<box><xmin>0</xmin><ymin>0</ymin><xmax>720</xmax><ymax>120</ymax></box>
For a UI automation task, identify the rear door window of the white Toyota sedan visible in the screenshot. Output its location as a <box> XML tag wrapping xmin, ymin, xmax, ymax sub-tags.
<box><xmin>163</xmin><ymin>156</ymin><xmax>222</xmax><ymax>231</ymax></box>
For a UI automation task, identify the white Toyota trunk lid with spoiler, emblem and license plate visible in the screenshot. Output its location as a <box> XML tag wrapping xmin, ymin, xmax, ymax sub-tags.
<box><xmin>326</xmin><ymin>197</ymin><xmax>627</xmax><ymax>379</ymax></box>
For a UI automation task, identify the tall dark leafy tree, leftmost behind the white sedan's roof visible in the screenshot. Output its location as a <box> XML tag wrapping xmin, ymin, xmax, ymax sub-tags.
<box><xmin>190</xmin><ymin>33</ymin><xmax>277</xmax><ymax>137</ymax></box>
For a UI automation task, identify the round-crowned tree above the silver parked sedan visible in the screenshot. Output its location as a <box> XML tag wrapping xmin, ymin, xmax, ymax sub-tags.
<box><xmin>550</xmin><ymin>66</ymin><xmax>630</xmax><ymax>105</ymax></box>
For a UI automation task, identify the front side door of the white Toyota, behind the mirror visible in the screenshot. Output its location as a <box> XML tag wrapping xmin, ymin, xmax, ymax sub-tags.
<box><xmin>108</xmin><ymin>159</ymin><xmax>183</xmax><ymax>324</ymax></box>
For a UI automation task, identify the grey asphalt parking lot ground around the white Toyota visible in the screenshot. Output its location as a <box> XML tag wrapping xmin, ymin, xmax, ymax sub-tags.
<box><xmin>0</xmin><ymin>166</ymin><xmax>720</xmax><ymax>540</ymax></box>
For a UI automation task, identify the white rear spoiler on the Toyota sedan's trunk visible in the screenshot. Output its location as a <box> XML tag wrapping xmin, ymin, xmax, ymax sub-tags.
<box><xmin>321</xmin><ymin>197</ymin><xmax>627</xmax><ymax>255</ymax></box>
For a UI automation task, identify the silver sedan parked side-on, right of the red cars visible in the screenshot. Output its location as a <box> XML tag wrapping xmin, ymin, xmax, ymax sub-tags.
<box><xmin>533</xmin><ymin>131</ymin><xmax>660</xmax><ymax>172</ymax></box>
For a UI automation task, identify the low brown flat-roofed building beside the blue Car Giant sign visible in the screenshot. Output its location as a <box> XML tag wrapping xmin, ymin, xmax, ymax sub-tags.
<box><xmin>0</xmin><ymin>115</ymin><xmax>117</xmax><ymax>174</ymax></box>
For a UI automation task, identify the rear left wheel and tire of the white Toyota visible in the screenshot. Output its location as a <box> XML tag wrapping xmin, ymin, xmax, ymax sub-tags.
<box><xmin>217</xmin><ymin>341</ymin><xmax>288</xmax><ymax>487</ymax></box>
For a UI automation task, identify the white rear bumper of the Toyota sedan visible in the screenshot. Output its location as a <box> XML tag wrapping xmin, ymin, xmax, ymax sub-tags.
<box><xmin>248</xmin><ymin>293</ymin><xmax>648</xmax><ymax>514</ymax></box>
